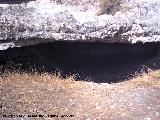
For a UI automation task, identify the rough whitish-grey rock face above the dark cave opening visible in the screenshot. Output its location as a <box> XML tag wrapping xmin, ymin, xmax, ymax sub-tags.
<box><xmin>0</xmin><ymin>0</ymin><xmax>160</xmax><ymax>50</ymax></box>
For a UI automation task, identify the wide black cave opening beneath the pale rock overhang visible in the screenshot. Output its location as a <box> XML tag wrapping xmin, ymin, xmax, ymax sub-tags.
<box><xmin>0</xmin><ymin>41</ymin><xmax>160</xmax><ymax>83</ymax></box>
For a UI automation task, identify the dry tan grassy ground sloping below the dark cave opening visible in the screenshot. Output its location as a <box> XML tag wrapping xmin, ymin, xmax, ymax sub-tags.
<box><xmin>0</xmin><ymin>71</ymin><xmax>160</xmax><ymax>120</ymax></box>
